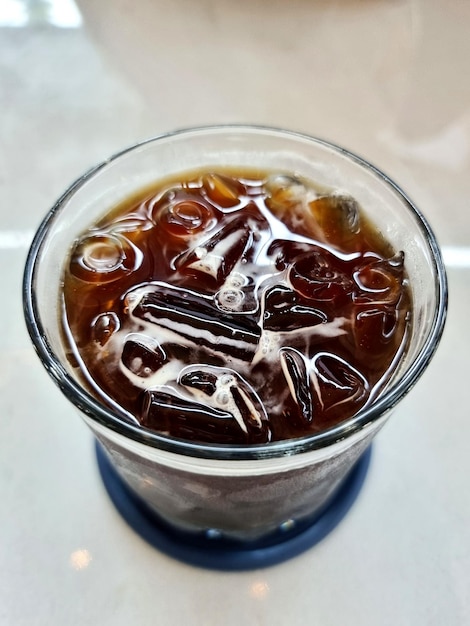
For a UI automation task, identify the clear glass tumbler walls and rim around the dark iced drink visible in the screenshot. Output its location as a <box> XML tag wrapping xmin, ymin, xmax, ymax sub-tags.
<box><xmin>24</xmin><ymin>126</ymin><xmax>447</xmax><ymax>552</ymax></box>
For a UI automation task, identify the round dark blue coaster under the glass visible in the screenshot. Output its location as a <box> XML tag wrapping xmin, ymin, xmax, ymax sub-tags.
<box><xmin>96</xmin><ymin>442</ymin><xmax>371</xmax><ymax>571</ymax></box>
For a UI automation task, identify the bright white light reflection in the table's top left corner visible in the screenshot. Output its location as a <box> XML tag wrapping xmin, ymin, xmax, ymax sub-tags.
<box><xmin>0</xmin><ymin>0</ymin><xmax>82</xmax><ymax>28</ymax></box>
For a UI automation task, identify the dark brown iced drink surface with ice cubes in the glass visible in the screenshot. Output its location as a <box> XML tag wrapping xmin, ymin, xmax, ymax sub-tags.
<box><xmin>63</xmin><ymin>170</ymin><xmax>410</xmax><ymax>444</ymax></box>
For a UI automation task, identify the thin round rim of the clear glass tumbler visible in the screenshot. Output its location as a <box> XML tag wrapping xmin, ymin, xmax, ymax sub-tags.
<box><xmin>23</xmin><ymin>124</ymin><xmax>448</xmax><ymax>460</ymax></box>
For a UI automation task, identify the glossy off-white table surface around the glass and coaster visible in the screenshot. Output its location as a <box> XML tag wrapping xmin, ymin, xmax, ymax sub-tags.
<box><xmin>0</xmin><ymin>0</ymin><xmax>470</xmax><ymax>626</ymax></box>
